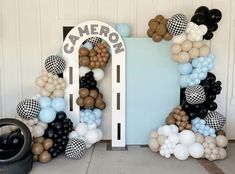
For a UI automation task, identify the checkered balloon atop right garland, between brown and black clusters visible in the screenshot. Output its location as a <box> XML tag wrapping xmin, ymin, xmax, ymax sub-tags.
<box><xmin>167</xmin><ymin>14</ymin><xmax>188</xmax><ymax>36</ymax></box>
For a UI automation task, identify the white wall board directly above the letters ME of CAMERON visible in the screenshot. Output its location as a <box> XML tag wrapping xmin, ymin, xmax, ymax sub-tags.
<box><xmin>78</xmin><ymin>0</ymin><xmax>98</xmax><ymax>23</ymax></box>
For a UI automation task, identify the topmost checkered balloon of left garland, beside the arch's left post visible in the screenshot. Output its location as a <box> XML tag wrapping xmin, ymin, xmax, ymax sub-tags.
<box><xmin>45</xmin><ymin>55</ymin><xmax>65</xmax><ymax>75</ymax></box>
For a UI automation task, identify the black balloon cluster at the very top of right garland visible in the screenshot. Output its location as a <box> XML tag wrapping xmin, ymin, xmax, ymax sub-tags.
<box><xmin>191</xmin><ymin>6</ymin><xmax>222</xmax><ymax>40</ymax></box>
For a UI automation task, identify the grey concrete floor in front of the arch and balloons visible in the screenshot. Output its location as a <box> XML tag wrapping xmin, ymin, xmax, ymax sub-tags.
<box><xmin>30</xmin><ymin>143</ymin><xmax>235</xmax><ymax>174</ymax></box>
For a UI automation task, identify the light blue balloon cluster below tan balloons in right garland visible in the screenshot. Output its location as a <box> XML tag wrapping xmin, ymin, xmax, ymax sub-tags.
<box><xmin>178</xmin><ymin>54</ymin><xmax>215</xmax><ymax>88</ymax></box>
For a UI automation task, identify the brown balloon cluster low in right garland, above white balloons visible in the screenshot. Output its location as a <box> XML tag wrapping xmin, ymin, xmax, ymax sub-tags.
<box><xmin>165</xmin><ymin>106</ymin><xmax>192</xmax><ymax>131</ymax></box>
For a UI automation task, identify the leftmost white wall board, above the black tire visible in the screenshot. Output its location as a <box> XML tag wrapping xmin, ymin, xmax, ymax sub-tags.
<box><xmin>1</xmin><ymin>0</ymin><xmax>21</xmax><ymax>117</ymax></box>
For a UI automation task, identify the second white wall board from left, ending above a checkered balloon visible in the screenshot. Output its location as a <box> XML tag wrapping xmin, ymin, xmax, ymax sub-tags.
<box><xmin>19</xmin><ymin>0</ymin><xmax>42</xmax><ymax>98</ymax></box>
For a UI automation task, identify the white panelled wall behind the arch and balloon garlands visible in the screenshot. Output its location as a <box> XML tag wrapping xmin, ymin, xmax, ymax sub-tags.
<box><xmin>0</xmin><ymin>0</ymin><xmax>235</xmax><ymax>139</ymax></box>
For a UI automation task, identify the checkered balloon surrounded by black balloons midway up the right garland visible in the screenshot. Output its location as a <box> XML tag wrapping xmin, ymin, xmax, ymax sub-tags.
<box><xmin>185</xmin><ymin>85</ymin><xmax>206</xmax><ymax>105</ymax></box>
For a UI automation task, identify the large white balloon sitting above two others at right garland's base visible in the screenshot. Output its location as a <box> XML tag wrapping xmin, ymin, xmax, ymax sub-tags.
<box><xmin>179</xmin><ymin>130</ymin><xmax>196</xmax><ymax>146</ymax></box>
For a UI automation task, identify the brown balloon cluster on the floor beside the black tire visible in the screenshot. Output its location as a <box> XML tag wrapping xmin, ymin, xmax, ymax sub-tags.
<box><xmin>32</xmin><ymin>137</ymin><xmax>53</xmax><ymax>163</ymax></box>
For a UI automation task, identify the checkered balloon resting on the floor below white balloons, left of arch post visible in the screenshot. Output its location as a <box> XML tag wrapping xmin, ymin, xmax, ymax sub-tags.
<box><xmin>65</xmin><ymin>138</ymin><xmax>86</xmax><ymax>159</ymax></box>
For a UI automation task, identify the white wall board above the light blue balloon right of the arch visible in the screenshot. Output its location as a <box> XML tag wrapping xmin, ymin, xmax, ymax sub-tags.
<box><xmin>117</xmin><ymin>0</ymin><xmax>137</xmax><ymax>37</ymax></box>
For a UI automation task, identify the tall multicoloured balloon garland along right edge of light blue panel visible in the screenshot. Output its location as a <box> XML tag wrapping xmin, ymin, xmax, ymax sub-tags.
<box><xmin>147</xmin><ymin>6</ymin><xmax>228</xmax><ymax>161</ymax></box>
